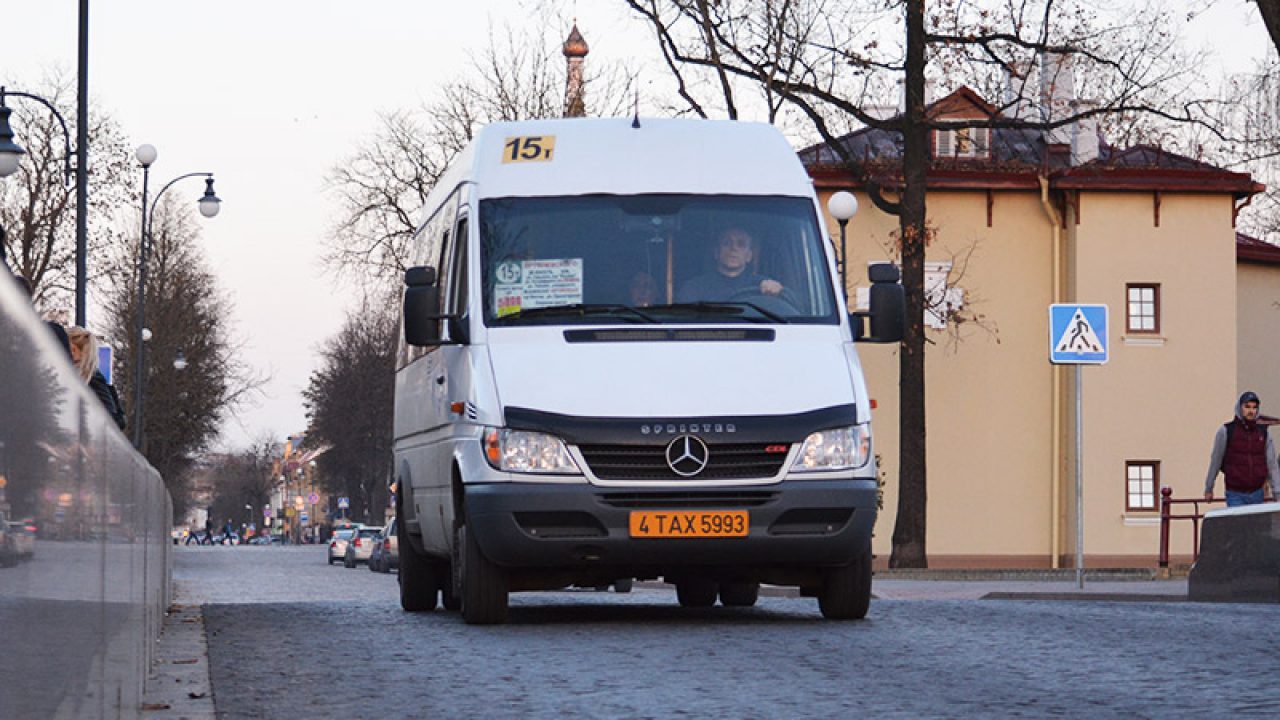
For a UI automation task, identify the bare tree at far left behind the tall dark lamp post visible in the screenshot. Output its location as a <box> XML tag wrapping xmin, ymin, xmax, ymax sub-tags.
<box><xmin>0</xmin><ymin>74</ymin><xmax>136</xmax><ymax>309</ymax></box>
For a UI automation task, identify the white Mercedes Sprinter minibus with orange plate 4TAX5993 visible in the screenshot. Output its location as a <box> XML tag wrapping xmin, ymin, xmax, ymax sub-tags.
<box><xmin>394</xmin><ymin>118</ymin><xmax>902</xmax><ymax>624</ymax></box>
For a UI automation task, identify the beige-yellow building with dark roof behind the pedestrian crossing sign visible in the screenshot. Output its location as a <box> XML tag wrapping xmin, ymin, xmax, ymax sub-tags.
<box><xmin>800</xmin><ymin>88</ymin><xmax>1259</xmax><ymax>568</ymax></box>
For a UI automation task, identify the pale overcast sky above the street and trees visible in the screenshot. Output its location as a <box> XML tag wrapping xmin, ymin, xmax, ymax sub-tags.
<box><xmin>0</xmin><ymin>0</ymin><xmax>1267</xmax><ymax>447</ymax></box>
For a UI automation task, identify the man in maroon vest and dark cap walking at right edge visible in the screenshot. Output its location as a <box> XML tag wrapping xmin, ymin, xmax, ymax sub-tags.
<box><xmin>1204</xmin><ymin>391</ymin><xmax>1280</xmax><ymax>507</ymax></box>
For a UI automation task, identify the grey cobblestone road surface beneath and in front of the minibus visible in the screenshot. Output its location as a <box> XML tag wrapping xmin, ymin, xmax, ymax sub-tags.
<box><xmin>185</xmin><ymin>547</ymin><xmax>1280</xmax><ymax>719</ymax></box>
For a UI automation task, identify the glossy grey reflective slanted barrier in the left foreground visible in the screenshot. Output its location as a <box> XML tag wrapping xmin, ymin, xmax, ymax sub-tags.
<box><xmin>0</xmin><ymin>269</ymin><xmax>172</xmax><ymax>719</ymax></box>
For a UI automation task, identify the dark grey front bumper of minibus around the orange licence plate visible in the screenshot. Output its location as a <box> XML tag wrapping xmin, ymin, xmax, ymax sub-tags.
<box><xmin>466</xmin><ymin>478</ymin><xmax>877</xmax><ymax>573</ymax></box>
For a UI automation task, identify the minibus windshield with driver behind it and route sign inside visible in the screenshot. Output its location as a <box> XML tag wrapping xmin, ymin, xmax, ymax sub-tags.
<box><xmin>480</xmin><ymin>195</ymin><xmax>838</xmax><ymax>325</ymax></box>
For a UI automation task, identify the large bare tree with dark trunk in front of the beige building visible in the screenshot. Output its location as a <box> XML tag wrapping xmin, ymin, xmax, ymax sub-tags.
<box><xmin>625</xmin><ymin>0</ymin><xmax>1212</xmax><ymax>568</ymax></box>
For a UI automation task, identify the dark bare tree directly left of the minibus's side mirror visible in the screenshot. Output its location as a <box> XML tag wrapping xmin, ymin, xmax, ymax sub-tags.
<box><xmin>302</xmin><ymin>297</ymin><xmax>399</xmax><ymax>521</ymax></box>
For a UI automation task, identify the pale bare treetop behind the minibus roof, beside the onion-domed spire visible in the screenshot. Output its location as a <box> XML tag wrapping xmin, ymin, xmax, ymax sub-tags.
<box><xmin>325</xmin><ymin>19</ymin><xmax>631</xmax><ymax>283</ymax></box>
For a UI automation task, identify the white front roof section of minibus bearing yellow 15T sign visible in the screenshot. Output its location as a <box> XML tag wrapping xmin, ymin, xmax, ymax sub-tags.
<box><xmin>458</xmin><ymin>118</ymin><xmax>813</xmax><ymax>197</ymax></box>
